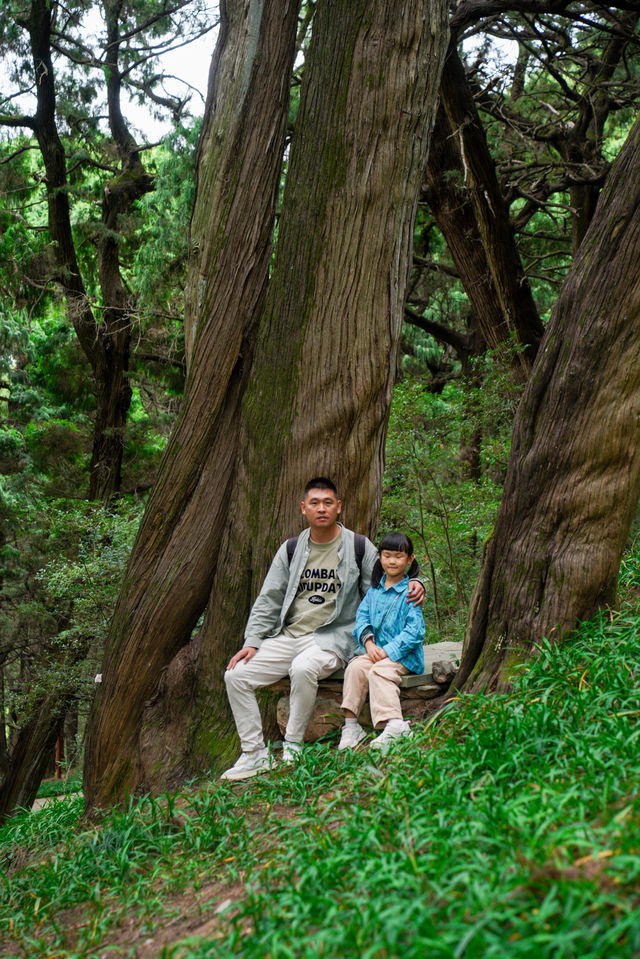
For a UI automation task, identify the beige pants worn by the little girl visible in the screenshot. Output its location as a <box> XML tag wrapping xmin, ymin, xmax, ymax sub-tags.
<box><xmin>342</xmin><ymin>656</ymin><xmax>409</xmax><ymax>729</ymax></box>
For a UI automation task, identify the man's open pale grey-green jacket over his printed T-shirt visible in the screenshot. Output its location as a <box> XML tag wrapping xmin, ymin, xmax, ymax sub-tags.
<box><xmin>244</xmin><ymin>524</ymin><xmax>378</xmax><ymax>663</ymax></box>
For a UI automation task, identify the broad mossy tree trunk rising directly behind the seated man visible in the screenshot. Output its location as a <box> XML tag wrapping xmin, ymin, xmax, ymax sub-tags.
<box><xmin>82</xmin><ymin>0</ymin><xmax>447</xmax><ymax>803</ymax></box>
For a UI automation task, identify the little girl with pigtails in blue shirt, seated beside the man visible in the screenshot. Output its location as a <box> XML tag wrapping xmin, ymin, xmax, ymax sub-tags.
<box><xmin>338</xmin><ymin>533</ymin><xmax>424</xmax><ymax>753</ymax></box>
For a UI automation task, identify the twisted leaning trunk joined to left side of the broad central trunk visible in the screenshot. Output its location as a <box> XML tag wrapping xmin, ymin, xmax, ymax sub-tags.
<box><xmin>85</xmin><ymin>0</ymin><xmax>298</xmax><ymax>803</ymax></box>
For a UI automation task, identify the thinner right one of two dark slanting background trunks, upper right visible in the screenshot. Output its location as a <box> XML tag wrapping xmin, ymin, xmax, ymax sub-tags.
<box><xmin>440</xmin><ymin>42</ymin><xmax>543</xmax><ymax>376</ymax></box>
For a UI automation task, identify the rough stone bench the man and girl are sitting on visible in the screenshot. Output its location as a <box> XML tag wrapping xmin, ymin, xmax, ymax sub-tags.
<box><xmin>267</xmin><ymin>642</ymin><xmax>462</xmax><ymax>742</ymax></box>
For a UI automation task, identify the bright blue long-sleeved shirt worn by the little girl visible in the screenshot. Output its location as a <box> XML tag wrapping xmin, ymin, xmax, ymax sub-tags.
<box><xmin>353</xmin><ymin>576</ymin><xmax>424</xmax><ymax>673</ymax></box>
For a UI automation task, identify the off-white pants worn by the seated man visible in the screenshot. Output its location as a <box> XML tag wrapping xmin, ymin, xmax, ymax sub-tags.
<box><xmin>224</xmin><ymin>635</ymin><xmax>342</xmax><ymax>753</ymax></box>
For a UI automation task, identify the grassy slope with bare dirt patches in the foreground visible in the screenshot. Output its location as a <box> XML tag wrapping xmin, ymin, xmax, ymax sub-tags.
<box><xmin>0</xmin><ymin>588</ymin><xmax>640</xmax><ymax>959</ymax></box>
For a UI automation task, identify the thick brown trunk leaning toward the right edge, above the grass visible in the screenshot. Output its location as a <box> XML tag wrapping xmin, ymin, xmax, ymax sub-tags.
<box><xmin>457</xmin><ymin>120</ymin><xmax>640</xmax><ymax>689</ymax></box>
